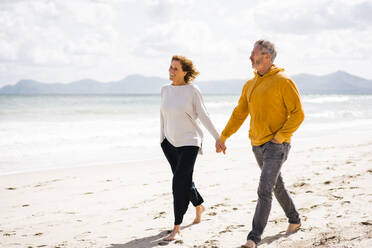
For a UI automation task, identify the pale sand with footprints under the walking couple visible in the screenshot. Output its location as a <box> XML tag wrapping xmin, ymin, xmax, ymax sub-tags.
<box><xmin>0</xmin><ymin>132</ymin><xmax>372</xmax><ymax>248</ymax></box>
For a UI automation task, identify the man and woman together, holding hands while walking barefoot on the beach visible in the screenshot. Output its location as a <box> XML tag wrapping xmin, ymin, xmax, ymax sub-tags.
<box><xmin>160</xmin><ymin>40</ymin><xmax>304</xmax><ymax>248</ymax></box>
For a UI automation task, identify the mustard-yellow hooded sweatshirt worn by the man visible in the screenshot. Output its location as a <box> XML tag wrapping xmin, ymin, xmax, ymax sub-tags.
<box><xmin>221</xmin><ymin>65</ymin><xmax>304</xmax><ymax>146</ymax></box>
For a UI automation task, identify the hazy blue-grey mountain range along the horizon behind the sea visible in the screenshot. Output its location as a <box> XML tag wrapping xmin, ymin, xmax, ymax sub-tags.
<box><xmin>0</xmin><ymin>71</ymin><xmax>372</xmax><ymax>95</ymax></box>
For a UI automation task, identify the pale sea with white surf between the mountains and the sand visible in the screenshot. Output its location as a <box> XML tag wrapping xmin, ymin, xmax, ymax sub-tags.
<box><xmin>0</xmin><ymin>95</ymin><xmax>372</xmax><ymax>174</ymax></box>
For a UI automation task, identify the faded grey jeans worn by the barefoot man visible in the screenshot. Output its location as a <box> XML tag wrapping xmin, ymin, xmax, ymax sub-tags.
<box><xmin>247</xmin><ymin>141</ymin><xmax>300</xmax><ymax>244</ymax></box>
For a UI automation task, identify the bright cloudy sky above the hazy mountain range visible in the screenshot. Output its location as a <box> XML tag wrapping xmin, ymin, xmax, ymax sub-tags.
<box><xmin>0</xmin><ymin>0</ymin><xmax>372</xmax><ymax>87</ymax></box>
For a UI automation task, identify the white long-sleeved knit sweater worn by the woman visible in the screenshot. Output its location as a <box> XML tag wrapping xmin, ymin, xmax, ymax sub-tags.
<box><xmin>160</xmin><ymin>84</ymin><xmax>219</xmax><ymax>151</ymax></box>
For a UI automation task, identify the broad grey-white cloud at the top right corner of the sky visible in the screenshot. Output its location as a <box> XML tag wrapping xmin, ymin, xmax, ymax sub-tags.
<box><xmin>255</xmin><ymin>0</ymin><xmax>371</xmax><ymax>35</ymax></box>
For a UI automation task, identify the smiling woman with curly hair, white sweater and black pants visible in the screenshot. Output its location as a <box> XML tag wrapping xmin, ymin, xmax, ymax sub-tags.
<box><xmin>160</xmin><ymin>56</ymin><xmax>219</xmax><ymax>241</ymax></box>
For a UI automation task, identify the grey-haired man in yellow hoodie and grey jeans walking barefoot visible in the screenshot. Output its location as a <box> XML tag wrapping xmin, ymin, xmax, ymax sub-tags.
<box><xmin>216</xmin><ymin>40</ymin><xmax>304</xmax><ymax>248</ymax></box>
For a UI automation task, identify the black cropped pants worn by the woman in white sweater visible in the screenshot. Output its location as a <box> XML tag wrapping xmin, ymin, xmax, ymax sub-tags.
<box><xmin>161</xmin><ymin>139</ymin><xmax>204</xmax><ymax>225</ymax></box>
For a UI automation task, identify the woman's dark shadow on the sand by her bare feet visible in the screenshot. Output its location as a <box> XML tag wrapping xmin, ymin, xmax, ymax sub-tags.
<box><xmin>107</xmin><ymin>224</ymin><xmax>193</xmax><ymax>248</ymax></box>
